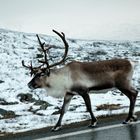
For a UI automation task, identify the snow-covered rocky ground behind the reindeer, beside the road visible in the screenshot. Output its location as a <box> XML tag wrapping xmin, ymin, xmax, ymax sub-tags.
<box><xmin>0</xmin><ymin>29</ymin><xmax>140</xmax><ymax>133</ymax></box>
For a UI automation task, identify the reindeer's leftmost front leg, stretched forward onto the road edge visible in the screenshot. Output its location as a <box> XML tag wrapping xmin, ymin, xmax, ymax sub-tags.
<box><xmin>52</xmin><ymin>92</ymin><xmax>73</xmax><ymax>131</ymax></box>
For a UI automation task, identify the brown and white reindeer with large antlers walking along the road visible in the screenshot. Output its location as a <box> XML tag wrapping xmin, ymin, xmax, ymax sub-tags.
<box><xmin>22</xmin><ymin>30</ymin><xmax>138</xmax><ymax>131</ymax></box>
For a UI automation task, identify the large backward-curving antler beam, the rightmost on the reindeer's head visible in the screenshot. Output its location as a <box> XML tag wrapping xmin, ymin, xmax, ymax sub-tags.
<box><xmin>49</xmin><ymin>30</ymin><xmax>69</xmax><ymax>68</ymax></box>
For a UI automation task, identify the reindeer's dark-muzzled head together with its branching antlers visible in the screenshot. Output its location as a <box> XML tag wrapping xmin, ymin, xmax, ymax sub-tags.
<box><xmin>22</xmin><ymin>30</ymin><xmax>69</xmax><ymax>89</ymax></box>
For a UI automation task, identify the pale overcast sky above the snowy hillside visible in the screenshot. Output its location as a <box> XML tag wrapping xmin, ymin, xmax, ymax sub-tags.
<box><xmin>0</xmin><ymin>0</ymin><xmax>140</xmax><ymax>40</ymax></box>
